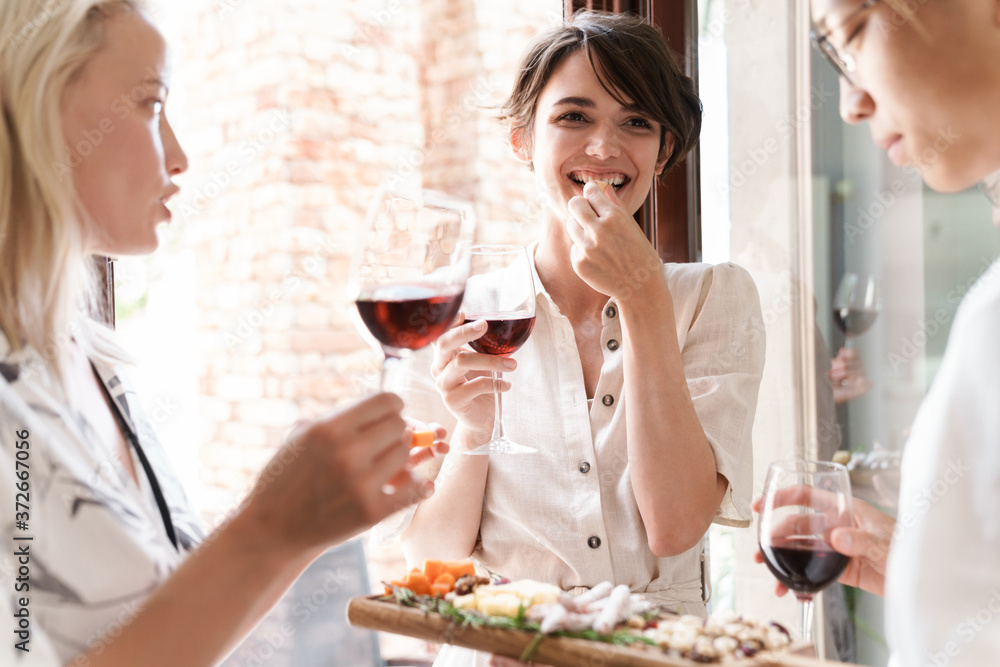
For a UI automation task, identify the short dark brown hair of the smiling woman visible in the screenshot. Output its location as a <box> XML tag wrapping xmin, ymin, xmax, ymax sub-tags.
<box><xmin>499</xmin><ymin>10</ymin><xmax>702</xmax><ymax>177</ymax></box>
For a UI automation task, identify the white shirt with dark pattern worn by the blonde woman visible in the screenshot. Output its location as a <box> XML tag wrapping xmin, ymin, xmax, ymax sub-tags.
<box><xmin>0</xmin><ymin>325</ymin><xmax>203</xmax><ymax>666</ymax></box>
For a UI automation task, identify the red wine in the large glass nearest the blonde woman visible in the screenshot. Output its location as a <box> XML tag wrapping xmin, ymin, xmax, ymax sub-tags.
<box><xmin>356</xmin><ymin>285</ymin><xmax>464</xmax><ymax>350</ymax></box>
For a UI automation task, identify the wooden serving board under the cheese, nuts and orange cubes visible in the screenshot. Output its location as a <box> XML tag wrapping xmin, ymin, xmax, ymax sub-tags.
<box><xmin>347</xmin><ymin>597</ymin><xmax>853</xmax><ymax>667</ymax></box>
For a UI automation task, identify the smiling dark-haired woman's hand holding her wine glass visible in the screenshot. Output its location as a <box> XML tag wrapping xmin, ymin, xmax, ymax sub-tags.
<box><xmin>431</xmin><ymin>313</ymin><xmax>517</xmax><ymax>442</ymax></box>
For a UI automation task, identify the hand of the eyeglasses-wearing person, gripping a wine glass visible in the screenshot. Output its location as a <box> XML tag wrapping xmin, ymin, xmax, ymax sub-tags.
<box><xmin>753</xmin><ymin>498</ymin><xmax>896</xmax><ymax>597</ymax></box>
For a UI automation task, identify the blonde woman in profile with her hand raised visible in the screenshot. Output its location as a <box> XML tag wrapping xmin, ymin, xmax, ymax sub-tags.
<box><xmin>0</xmin><ymin>0</ymin><xmax>442</xmax><ymax>667</ymax></box>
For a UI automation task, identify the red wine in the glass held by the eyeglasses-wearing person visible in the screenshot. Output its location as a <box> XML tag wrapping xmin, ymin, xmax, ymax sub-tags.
<box><xmin>760</xmin><ymin>537</ymin><xmax>849</xmax><ymax>593</ymax></box>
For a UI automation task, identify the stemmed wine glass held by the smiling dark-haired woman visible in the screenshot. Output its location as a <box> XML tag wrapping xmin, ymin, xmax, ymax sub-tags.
<box><xmin>463</xmin><ymin>245</ymin><xmax>537</xmax><ymax>454</ymax></box>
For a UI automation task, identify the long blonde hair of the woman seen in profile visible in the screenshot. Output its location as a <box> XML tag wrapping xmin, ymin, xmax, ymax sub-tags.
<box><xmin>0</xmin><ymin>0</ymin><xmax>143</xmax><ymax>382</ymax></box>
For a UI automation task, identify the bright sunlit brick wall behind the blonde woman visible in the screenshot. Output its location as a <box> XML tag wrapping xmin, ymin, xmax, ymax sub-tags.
<box><xmin>131</xmin><ymin>0</ymin><xmax>562</xmax><ymax>654</ymax></box>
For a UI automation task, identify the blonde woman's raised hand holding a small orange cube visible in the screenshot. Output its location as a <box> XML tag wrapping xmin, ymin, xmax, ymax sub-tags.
<box><xmin>242</xmin><ymin>394</ymin><xmax>432</xmax><ymax>557</ymax></box>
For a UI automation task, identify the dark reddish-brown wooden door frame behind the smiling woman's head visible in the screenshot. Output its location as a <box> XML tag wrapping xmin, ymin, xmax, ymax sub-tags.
<box><xmin>563</xmin><ymin>0</ymin><xmax>701</xmax><ymax>262</ymax></box>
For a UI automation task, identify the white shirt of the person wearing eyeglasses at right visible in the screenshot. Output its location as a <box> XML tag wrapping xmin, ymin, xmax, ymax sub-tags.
<box><xmin>886</xmin><ymin>262</ymin><xmax>1000</xmax><ymax>667</ymax></box>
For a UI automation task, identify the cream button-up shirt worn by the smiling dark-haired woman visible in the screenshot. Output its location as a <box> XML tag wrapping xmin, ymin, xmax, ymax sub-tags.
<box><xmin>373</xmin><ymin>253</ymin><xmax>764</xmax><ymax>665</ymax></box>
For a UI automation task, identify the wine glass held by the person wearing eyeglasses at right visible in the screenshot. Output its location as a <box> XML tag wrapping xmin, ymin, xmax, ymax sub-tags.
<box><xmin>757</xmin><ymin>460</ymin><xmax>854</xmax><ymax>642</ymax></box>
